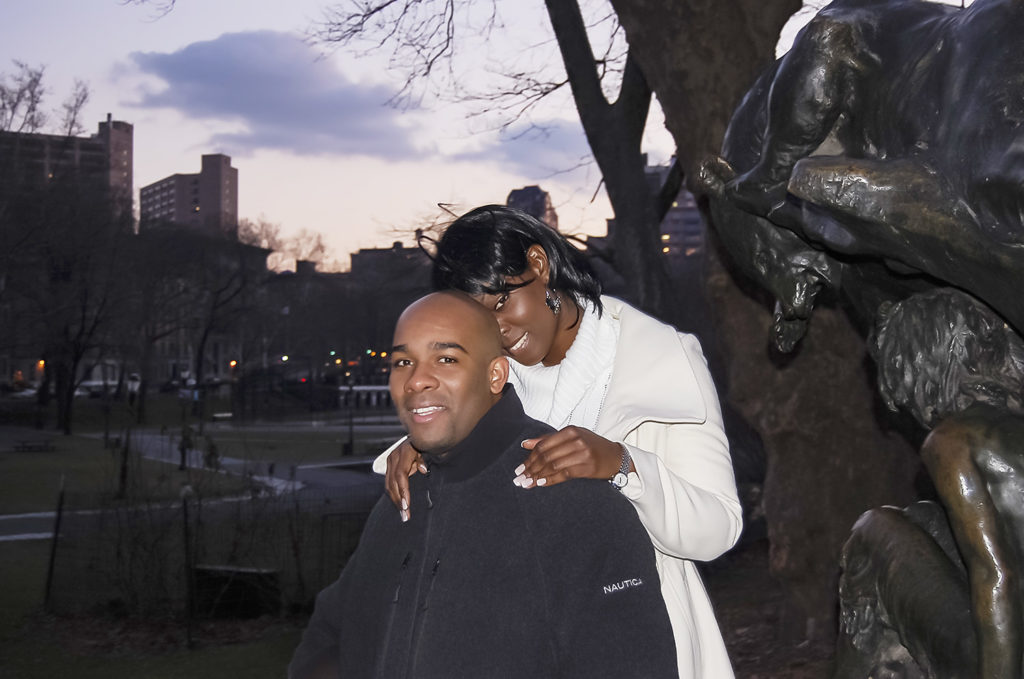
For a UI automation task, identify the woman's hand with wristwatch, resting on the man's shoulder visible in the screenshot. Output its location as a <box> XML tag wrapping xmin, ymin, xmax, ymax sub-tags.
<box><xmin>516</xmin><ymin>427</ymin><xmax>632</xmax><ymax>489</ymax></box>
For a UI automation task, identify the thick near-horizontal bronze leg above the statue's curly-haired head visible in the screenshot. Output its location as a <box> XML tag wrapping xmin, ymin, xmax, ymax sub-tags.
<box><xmin>775</xmin><ymin>156</ymin><xmax>1024</xmax><ymax>329</ymax></box>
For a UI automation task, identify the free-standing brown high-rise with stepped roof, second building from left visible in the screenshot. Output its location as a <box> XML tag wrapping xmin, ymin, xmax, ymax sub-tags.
<box><xmin>139</xmin><ymin>154</ymin><xmax>239</xmax><ymax>239</ymax></box>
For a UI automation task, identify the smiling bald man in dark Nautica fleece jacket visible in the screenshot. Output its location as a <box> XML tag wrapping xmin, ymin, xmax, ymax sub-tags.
<box><xmin>289</xmin><ymin>292</ymin><xmax>677</xmax><ymax>679</ymax></box>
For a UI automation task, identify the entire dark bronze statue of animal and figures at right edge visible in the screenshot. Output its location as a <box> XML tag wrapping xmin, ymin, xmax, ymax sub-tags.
<box><xmin>700</xmin><ymin>0</ymin><xmax>1024</xmax><ymax>679</ymax></box>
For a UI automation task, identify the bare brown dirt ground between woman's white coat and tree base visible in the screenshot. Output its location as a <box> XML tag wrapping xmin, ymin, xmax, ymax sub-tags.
<box><xmin>705</xmin><ymin>540</ymin><xmax>834</xmax><ymax>679</ymax></box>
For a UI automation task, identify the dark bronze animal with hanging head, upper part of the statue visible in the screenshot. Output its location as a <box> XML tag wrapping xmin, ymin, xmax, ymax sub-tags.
<box><xmin>700</xmin><ymin>0</ymin><xmax>1024</xmax><ymax>350</ymax></box>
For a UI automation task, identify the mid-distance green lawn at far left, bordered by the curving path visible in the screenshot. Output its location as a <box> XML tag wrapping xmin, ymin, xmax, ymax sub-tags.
<box><xmin>0</xmin><ymin>436</ymin><xmax>249</xmax><ymax>514</ymax></box>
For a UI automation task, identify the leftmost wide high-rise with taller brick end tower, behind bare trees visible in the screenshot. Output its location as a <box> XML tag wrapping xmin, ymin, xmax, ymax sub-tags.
<box><xmin>0</xmin><ymin>114</ymin><xmax>134</xmax><ymax>214</ymax></box>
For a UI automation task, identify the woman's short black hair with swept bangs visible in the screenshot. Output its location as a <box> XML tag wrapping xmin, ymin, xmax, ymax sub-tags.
<box><xmin>433</xmin><ymin>205</ymin><xmax>601</xmax><ymax>313</ymax></box>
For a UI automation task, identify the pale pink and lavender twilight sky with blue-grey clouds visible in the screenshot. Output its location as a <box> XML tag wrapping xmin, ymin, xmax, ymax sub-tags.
<box><xmin>0</xmin><ymin>0</ymin><xmax>958</xmax><ymax>268</ymax></box>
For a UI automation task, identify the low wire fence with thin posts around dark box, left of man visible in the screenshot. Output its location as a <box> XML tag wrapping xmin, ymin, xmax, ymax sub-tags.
<box><xmin>47</xmin><ymin>490</ymin><xmax>379</xmax><ymax>622</ymax></box>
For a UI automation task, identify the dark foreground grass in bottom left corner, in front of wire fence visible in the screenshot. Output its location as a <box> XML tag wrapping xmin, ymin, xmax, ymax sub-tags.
<box><xmin>0</xmin><ymin>541</ymin><xmax>300</xmax><ymax>679</ymax></box>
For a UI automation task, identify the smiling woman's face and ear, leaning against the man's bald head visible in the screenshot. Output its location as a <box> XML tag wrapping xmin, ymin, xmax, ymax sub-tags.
<box><xmin>474</xmin><ymin>245</ymin><xmax>579</xmax><ymax>366</ymax></box>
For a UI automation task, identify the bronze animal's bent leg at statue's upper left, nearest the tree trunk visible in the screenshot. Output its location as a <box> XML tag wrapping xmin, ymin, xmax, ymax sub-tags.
<box><xmin>726</xmin><ymin>12</ymin><xmax>873</xmax><ymax>215</ymax></box>
